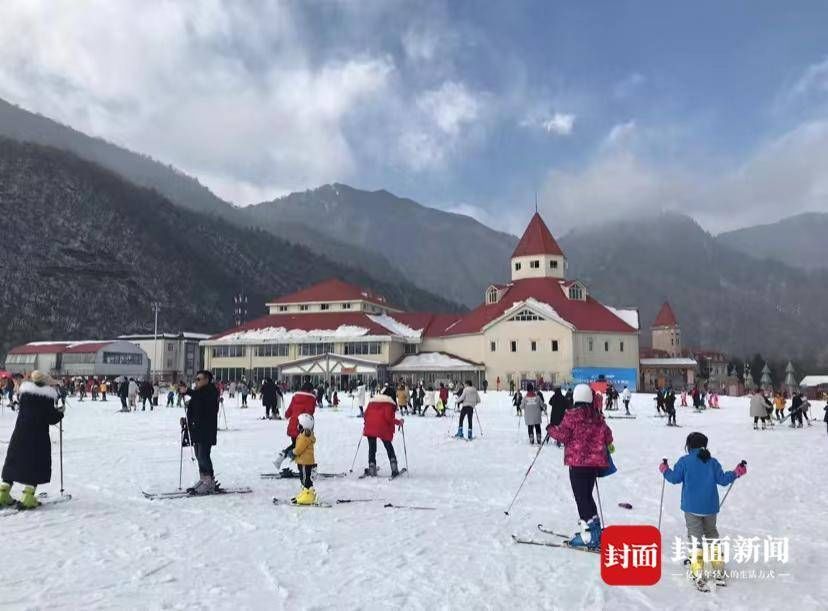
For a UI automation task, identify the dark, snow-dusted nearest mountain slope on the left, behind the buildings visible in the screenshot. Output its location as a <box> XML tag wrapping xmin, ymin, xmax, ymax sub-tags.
<box><xmin>0</xmin><ymin>138</ymin><xmax>457</xmax><ymax>364</ymax></box>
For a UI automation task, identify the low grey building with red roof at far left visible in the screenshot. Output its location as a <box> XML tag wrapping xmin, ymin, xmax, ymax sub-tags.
<box><xmin>5</xmin><ymin>340</ymin><xmax>149</xmax><ymax>378</ymax></box>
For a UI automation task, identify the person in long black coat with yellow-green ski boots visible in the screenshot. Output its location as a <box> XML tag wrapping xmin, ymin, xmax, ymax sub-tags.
<box><xmin>0</xmin><ymin>370</ymin><xmax>63</xmax><ymax>509</ymax></box>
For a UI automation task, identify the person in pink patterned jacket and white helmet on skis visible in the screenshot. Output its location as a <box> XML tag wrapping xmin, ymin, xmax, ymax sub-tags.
<box><xmin>546</xmin><ymin>384</ymin><xmax>615</xmax><ymax>549</ymax></box>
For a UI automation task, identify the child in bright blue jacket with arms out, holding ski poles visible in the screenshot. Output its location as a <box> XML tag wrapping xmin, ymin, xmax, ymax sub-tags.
<box><xmin>658</xmin><ymin>433</ymin><xmax>747</xmax><ymax>589</ymax></box>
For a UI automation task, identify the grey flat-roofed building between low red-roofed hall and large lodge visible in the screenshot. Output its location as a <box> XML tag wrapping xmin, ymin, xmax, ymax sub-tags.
<box><xmin>118</xmin><ymin>332</ymin><xmax>210</xmax><ymax>382</ymax></box>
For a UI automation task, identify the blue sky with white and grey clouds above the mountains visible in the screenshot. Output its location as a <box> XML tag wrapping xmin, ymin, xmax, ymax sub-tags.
<box><xmin>0</xmin><ymin>0</ymin><xmax>828</xmax><ymax>233</ymax></box>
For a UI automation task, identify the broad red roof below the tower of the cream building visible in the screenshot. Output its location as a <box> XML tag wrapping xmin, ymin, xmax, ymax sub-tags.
<box><xmin>442</xmin><ymin>278</ymin><xmax>636</xmax><ymax>335</ymax></box>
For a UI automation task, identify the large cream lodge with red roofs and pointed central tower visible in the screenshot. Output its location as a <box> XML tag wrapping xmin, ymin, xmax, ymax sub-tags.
<box><xmin>202</xmin><ymin>213</ymin><xmax>639</xmax><ymax>389</ymax></box>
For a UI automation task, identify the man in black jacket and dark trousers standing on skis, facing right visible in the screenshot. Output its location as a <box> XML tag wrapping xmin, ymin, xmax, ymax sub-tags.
<box><xmin>178</xmin><ymin>369</ymin><xmax>219</xmax><ymax>494</ymax></box>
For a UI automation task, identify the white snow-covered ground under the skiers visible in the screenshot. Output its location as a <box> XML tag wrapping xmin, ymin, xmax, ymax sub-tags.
<box><xmin>0</xmin><ymin>392</ymin><xmax>828</xmax><ymax>610</ymax></box>
